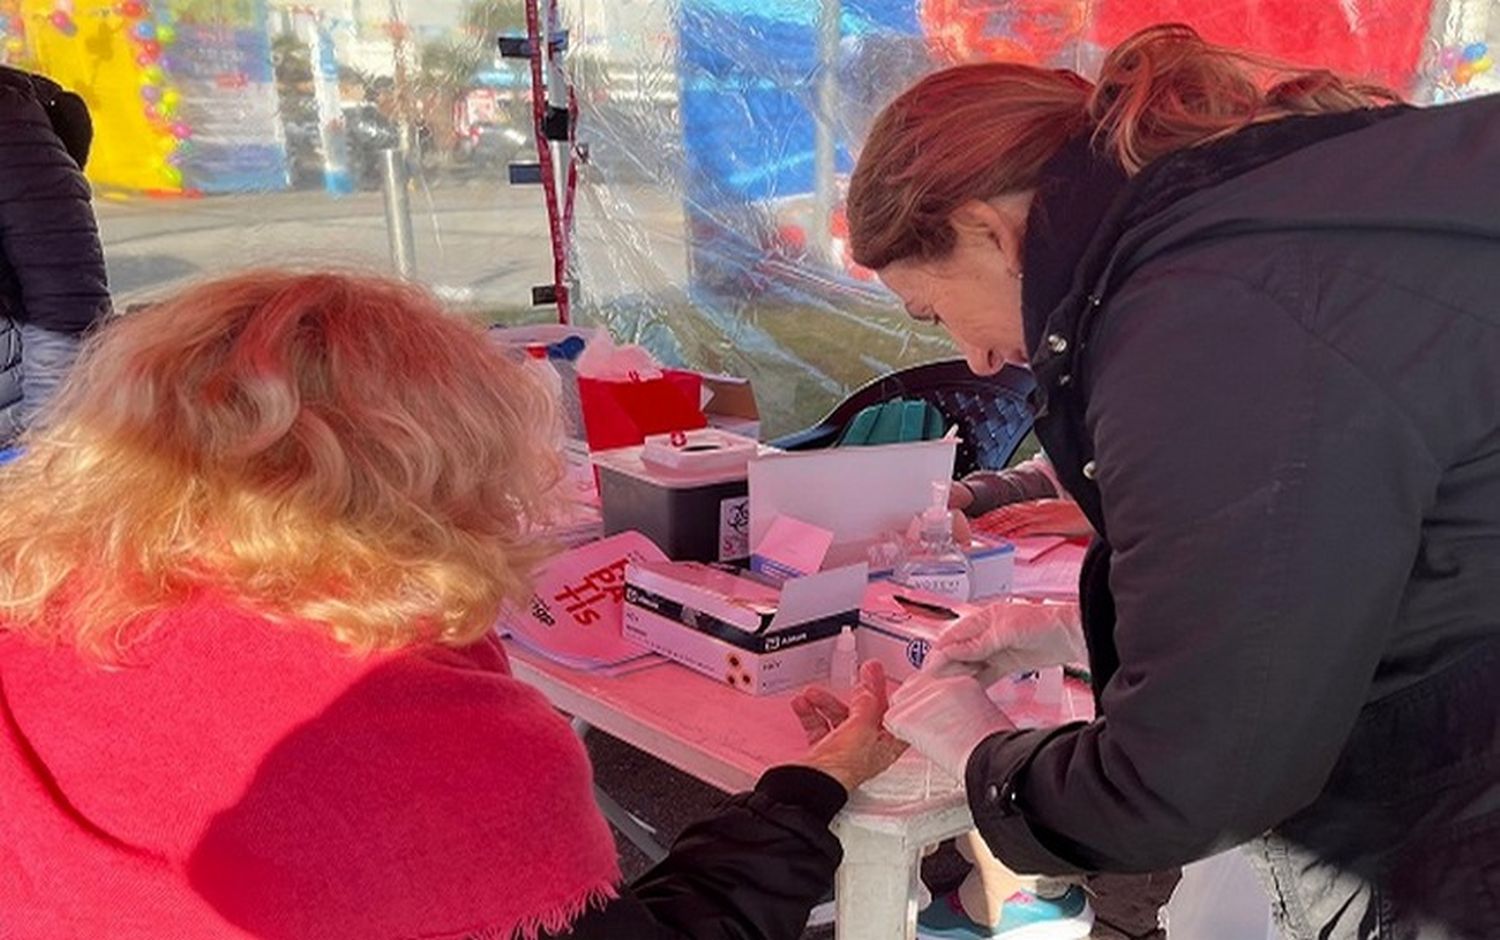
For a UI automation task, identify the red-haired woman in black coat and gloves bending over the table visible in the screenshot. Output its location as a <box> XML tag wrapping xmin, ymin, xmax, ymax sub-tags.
<box><xmin>848</xmin><ymin>25</ymin><xmax>1500</xmax><ymax>940</ymax></box>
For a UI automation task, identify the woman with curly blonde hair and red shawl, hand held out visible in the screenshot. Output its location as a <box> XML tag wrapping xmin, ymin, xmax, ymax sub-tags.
<box><xmin>0</xmin><ymin>271</ymin><xmax>900</xmax><ymax>940</ymax></box>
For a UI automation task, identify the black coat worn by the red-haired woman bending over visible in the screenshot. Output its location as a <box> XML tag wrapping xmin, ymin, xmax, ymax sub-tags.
<box><xmin>968</xmin><ymin>99</ymin><xmax>1500</xmax><ymax>939</ymax></box>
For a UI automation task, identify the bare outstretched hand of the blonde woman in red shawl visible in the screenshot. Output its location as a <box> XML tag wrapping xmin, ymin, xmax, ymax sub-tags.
<box><xmin>792</xmin><ymin>663</ymin><xmax>906</xmax><ymax>793</ymax></box>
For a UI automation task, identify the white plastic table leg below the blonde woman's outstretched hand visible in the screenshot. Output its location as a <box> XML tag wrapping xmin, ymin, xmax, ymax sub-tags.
<box><xmin>834</xmin><ymin>819</ymin><xmax>921</xmax><ymax>940</ymax></box>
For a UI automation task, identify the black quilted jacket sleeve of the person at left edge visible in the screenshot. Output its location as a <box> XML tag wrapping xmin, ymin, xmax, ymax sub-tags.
<box><xmin>0</xmin><ymin>82</ymin><xmax>110</xmax><ymax>333</ymax></box>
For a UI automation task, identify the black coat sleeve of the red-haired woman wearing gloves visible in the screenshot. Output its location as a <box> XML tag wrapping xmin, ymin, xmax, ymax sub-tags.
<box><xmin>966</xmin><ymin>270</ymin><xmax>1440</xmax><ymax>874</ymax></box>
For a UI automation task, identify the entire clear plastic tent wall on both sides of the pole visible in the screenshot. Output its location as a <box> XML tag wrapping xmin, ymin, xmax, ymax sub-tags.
<box><xmin>0</xmin><ymin>0</ymin><xmax>1500</xmax><ymax>435</ymax></box>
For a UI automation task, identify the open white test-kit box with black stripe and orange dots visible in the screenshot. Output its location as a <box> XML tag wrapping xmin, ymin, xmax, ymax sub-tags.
<box><xmin>623</xmin><ymin>562</ymin><xmax>867</xmax><ymax>696</ymax></box>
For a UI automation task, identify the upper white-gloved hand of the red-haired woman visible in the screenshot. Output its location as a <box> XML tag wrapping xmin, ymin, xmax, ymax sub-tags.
<box><xmin>923</xmin><ymin>598</ymin><xmax>1089</xmax><ymax>688</ymax></box>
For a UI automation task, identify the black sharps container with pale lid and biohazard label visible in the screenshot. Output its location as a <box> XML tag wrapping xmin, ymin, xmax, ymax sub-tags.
<box><xmin>594</xmin><ymin>427</ymin><xmax>759</xmax><ymax>562</ymax></box>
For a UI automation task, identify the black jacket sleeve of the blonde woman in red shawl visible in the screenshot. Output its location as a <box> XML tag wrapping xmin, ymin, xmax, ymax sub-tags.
<box><xmin>557</xmin><ymin>768</ymin><xmax>848</xmax><ymax>940</ymax></box>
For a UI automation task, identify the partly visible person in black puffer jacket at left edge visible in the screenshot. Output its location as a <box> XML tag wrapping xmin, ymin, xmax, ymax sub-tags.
<box><xmin>0</xmin><ymin>67</ymin><xmax>111</xmax><ymax>444</ymax></box>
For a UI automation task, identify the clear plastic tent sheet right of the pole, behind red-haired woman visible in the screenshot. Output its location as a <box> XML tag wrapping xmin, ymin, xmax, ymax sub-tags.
<box><xmin>563</xmin><ymin>0</ymin><xmax>1490</xmax><ymax>430</ymax></box>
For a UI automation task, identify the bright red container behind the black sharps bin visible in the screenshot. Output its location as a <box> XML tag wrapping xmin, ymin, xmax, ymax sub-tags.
<box><xmin>578</xmin><ymin>369</ymin><xmax>708</xmax><ymax>450</ymax></box>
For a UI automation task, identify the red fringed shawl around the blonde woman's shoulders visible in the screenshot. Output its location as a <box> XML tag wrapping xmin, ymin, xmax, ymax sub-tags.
<box><xmin>0</xmin><ymin>600</ymin><xmax>620</xmax><ymax>940</ymax></box>
